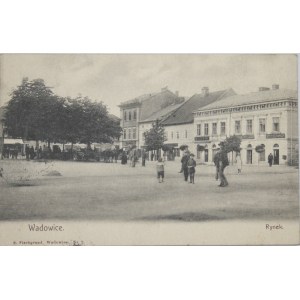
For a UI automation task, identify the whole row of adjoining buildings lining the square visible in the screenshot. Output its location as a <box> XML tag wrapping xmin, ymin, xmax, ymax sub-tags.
<box><xmin>119</xmin><ymin>84</ymin><xmax>298</xmax><ymax>165</ymax></box>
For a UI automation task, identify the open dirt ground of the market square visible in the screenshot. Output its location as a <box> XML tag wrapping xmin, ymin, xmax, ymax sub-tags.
<box><xmin>0</xmin><ymin>160</ymin><xmax>299</xmax><ymax>222</ymax></box>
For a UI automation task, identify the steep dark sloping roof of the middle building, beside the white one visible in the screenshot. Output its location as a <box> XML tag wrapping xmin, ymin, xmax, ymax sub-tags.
<box><xmin>162</xmin><ymin>88</ymin><xmax>236</xmax><ymax>126</ymax></box>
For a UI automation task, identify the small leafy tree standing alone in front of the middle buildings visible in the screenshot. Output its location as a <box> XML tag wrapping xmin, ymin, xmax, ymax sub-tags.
<box><xmin>144</xmin><ymin>120</ymin><xmax>165</xmax><ymax>155</ymax></box>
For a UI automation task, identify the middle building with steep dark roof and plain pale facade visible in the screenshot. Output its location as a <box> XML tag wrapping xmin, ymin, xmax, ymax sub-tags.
<box><xmin>162</xmin><ymin>87</ymin><xmax>236</xmax><ymax>156</ymax></box>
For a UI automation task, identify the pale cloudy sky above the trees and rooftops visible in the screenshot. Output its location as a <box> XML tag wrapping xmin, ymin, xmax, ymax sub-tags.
<box><xmin>0</xmin><ymin>54</ymin><xmax>297</xmax><ymax>116</ymax></box>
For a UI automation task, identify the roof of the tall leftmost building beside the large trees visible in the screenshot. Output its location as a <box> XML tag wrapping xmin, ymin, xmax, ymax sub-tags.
<box><xmin>119</xmin><ymin>88</ymin><xmax>184</xmax><ymax>121</ymax></box>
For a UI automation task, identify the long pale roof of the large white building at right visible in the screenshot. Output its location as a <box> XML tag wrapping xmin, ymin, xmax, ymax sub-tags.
<box><xmin>198</xmin><ymin>89</ymin><xmax>298</xmax><ymax>111</ymax></box>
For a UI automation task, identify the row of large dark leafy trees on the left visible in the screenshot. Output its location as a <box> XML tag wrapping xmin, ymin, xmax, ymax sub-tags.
<box><xmin>5</xmin><ymin>78</ymin><xmax>122</xmax><ymax>147</ymax></box>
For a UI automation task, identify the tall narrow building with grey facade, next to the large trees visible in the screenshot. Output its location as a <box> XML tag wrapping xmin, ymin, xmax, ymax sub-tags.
<box><xmin>119</xmin><ymin>87</ymin><xmax>184</xmax><ymax>148</ymax></box>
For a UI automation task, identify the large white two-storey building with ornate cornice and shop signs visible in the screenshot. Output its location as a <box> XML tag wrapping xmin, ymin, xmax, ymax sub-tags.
<box><xmin>193</xmin><ymin>84</ymin><xmax>298</xmax><ymax>165</ymax></box>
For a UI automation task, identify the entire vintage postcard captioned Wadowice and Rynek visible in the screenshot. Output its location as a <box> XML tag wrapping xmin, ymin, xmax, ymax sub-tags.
<box><xmin>0</xmin><ymin>54</ymin><xmax>299</xmax><ymax>246</ymax></box>
